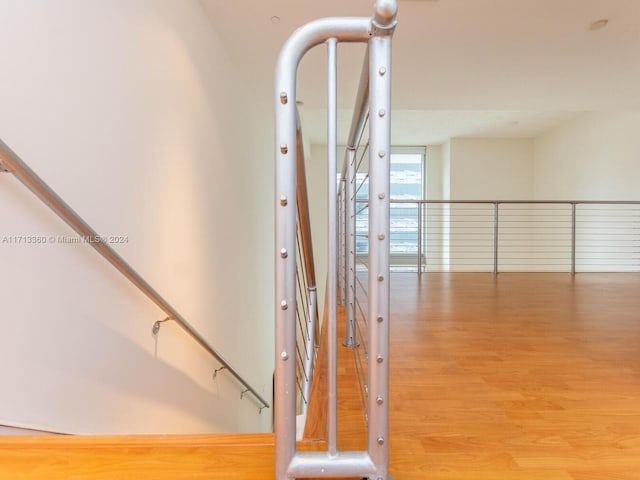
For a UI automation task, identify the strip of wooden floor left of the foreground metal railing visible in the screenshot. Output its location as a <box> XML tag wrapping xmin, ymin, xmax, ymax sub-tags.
<box><xmin>0</xmin><ymin>434</ymin><xmax>273</xmax><ymax>480</ymax></box>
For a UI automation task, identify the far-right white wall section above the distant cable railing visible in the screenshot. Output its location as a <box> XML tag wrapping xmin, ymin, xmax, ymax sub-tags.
<box><xmin>534</xmin><ymin>112</ymin><xmax>640</xmax><ymax>200</ymax></box>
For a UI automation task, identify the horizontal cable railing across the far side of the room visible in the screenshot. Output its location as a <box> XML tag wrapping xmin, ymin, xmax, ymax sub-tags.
<box><xmin>390</xmin><ymin>199</ymin><xmax>640</xmax><ymax>273</ymax></box>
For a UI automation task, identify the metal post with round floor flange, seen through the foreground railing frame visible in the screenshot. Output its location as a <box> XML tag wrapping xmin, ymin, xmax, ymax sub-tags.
<box><xmin>342</xmin><ymin>147</ymin><xmax>358</xmax><ymax>347</ymax></box>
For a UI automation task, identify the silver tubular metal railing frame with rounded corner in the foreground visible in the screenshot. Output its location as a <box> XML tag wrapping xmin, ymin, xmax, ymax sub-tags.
<box><xmin>274</xmin><ymin>0</ymin><xmax>397</xmax><ymax>480</ymax></box>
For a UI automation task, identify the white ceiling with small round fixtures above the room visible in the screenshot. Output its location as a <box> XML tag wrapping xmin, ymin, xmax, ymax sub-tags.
<box><xmin>201</xmin><ymin>0</ymin><xmax>640</xmax><ymax>144</ymax></box>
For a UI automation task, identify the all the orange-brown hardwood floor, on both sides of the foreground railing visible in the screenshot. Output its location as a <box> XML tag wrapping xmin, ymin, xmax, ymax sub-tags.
<box><xmin>0</xmin><ymin>274</ymin><xmax>640</xmax><ymax>480</ymax></box>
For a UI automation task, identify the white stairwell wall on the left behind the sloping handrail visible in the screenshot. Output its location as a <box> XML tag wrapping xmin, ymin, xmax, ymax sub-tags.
<box><xmin>0</xmin><ymin>0</ymin><xmax>273</xmax><ymax>434</ymax></box>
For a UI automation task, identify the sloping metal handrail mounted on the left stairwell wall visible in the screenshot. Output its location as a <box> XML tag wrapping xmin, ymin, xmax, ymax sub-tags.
<box><xmin>0</xmin><ymin>136</ymin><xmax>269</xmax><ymax>407</ymax></box>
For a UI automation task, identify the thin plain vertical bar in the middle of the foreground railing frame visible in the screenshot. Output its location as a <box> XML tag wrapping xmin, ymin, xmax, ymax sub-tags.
<box><xmin>327</xmin><ymin>38</ymin><xmax>338</xmax><ymax>455</ymax></box>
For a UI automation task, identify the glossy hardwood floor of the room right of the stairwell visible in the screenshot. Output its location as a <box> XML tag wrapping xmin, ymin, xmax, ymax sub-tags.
<box><xmin>304</xmin><ymin>273</ymin><xmax>640</xmax><ymax>480</ymax></box>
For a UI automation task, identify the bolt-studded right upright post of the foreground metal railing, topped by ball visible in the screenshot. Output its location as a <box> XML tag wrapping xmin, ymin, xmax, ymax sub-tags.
<box><xmin>367</xmin><ymin>11</ymin><xmax>396</xmax><ymax>479</ymax></box>
